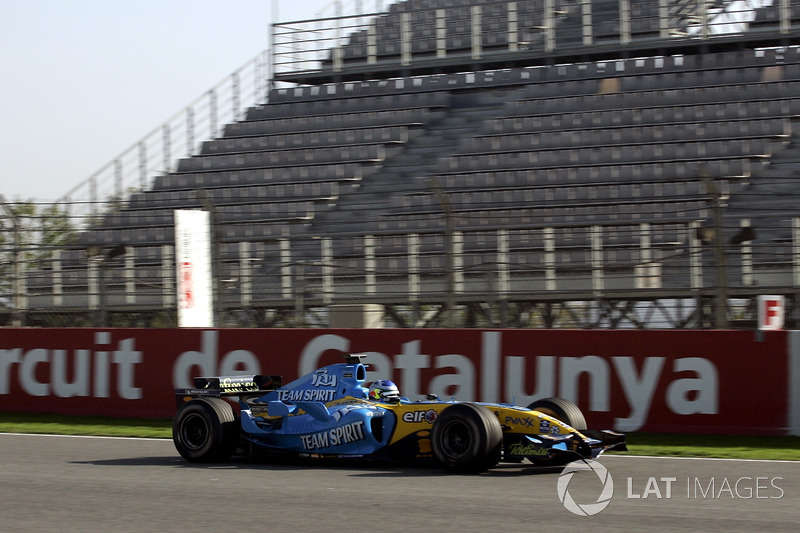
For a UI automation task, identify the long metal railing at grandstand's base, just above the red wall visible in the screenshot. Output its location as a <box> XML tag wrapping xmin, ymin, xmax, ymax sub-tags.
<box><xmin>6</xmin><ymin>212</ymin><xmax>800</xmax><ymax>328</ymax></box>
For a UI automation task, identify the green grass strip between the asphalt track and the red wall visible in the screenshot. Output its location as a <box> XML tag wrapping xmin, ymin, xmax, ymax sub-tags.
<box><xmin>0</xmin><ymin>413</ymin><xmax>800</xmax><ymax>461</ymax></box>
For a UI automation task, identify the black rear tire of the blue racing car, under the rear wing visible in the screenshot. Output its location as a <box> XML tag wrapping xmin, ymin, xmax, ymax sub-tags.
<box><xmin>172</xmin><ymin>398</ymin><xmax>239</xmax><ymax>463</ymax></box>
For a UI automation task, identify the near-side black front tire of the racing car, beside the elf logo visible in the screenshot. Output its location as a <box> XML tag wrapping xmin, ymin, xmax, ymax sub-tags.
<box><xmin>431</xmin><ymin>403</ymin><xmax>503</xmax><ymax>474</ymax></box>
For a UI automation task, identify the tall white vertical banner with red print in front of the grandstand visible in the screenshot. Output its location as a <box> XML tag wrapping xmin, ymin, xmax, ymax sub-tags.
<box><xmin>175</xmin><ymin>209</ymin><xmax>214</xmax><ymax>328</ymax></box>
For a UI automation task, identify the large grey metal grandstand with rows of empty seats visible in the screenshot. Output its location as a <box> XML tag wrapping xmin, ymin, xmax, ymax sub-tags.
<box><xmin>17</xmin><ymin>0</ymin><xmax>800</xmax><ymax>328</ymax></box>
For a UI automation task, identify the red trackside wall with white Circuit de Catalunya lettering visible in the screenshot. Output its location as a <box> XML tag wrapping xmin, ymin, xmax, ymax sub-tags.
<box><xmin>0</xmin><ymin>328</ymin><xmax>790</xmax><ymax>434</ymax></box>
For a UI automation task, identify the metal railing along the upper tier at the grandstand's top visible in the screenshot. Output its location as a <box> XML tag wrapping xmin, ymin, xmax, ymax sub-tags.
<box><xmin>271</xmin><ymin>0</ymin><xmax>797</xmax><ymax>81</ymax></box>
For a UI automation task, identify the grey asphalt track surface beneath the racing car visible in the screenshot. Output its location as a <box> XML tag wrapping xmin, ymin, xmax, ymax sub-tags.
<box><xmin>0</xmin><ymin>434</ymin><xmax>800</xmax><ymax>533</ymax></box>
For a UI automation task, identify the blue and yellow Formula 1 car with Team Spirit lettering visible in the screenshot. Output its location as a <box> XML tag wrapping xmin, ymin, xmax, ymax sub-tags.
<box><xmin>172</xmin><ymin>355</ymin><xmax>627</xmax><ymax>473</ymax></box>
